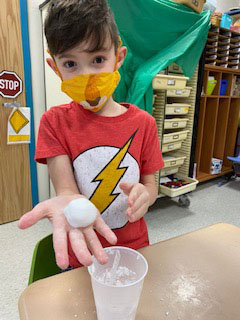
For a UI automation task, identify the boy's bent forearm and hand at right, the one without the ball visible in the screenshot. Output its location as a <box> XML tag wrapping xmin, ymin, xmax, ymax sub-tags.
<box><xmin>120</xmin><ymin>174</ymin><xmax>157</xmax><ymax>222</ymax></box>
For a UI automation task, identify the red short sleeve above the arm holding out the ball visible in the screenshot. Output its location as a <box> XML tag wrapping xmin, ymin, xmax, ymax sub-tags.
<box><xmin>35</xmin><ymin>113</ymin><xmax>67</xmax><ymax>164</ymax></box>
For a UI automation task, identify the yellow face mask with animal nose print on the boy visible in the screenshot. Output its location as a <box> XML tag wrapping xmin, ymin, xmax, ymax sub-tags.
<box><xmin>50</xmin><ymin>41</ymin><xmax>122</xmax><ymax>112</ymax></box>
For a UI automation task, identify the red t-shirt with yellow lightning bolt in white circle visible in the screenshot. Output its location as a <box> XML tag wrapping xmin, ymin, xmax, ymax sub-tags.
<box><xmin>36</xmin><ymin>101</ymin><xmax>163</xmax><ymax>267</ymax></box>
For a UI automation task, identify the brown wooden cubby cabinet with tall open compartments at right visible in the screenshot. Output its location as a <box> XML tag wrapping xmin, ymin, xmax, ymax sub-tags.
<box><xmin>195</xmin><ymin>65</ymin><xmax>240</xmax><ymax>181</ymax></box>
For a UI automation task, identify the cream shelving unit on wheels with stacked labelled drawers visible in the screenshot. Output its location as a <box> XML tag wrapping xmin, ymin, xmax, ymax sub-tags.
<box><xmin>153</xmin><ymin>65</ymin><xmax>198</xmax><ymax>203</ymax></box>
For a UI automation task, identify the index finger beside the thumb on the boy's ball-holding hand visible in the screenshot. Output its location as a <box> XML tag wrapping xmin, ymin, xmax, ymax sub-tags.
<box><xmin>53</xmin><ymin>215</ymin><xmax>69</xmax><ymax>269</ymax></box>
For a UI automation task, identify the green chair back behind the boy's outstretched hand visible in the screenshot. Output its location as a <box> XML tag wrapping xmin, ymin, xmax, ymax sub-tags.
<box><xmin>28</xmin><ymin>234</ymin><xmax>61</xmax><ymax>285</ymax></box>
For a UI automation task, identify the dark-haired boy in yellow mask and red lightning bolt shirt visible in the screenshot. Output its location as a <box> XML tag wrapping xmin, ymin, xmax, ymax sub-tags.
<box><xmin>19</xmin><ymin>0</ymin><xmax>163</xmax><ymax>269</ymax></box>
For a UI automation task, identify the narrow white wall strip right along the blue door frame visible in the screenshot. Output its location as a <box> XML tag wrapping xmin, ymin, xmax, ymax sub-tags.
<box><xmin>28</xmin><ymin>0</ymin><xmax>49</xmax><ymax>201</ymax></box>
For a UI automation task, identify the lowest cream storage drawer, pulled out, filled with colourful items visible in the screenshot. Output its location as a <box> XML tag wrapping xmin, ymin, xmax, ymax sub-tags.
<box><xmin>160</xmin><ymin>173</ymin><xmax>198</xmax><ymax>198</ymax></box>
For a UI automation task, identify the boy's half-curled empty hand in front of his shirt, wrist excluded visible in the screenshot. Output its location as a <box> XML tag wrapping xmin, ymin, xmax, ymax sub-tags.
<box><xmin>120</xmin><ymin>182</ymin><xmax>150</xmax><ymax>222</ymax></box>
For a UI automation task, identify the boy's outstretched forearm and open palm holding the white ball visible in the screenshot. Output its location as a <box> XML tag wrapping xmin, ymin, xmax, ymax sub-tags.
<box><xmin>19</xmin><ymin>155</ymin><xmax>117</xmax><ymax>269</ymax></box>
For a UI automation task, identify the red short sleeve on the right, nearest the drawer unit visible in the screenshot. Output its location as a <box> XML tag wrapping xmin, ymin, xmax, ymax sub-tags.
<box><xmin>141</xmin><ymin>117</ymin><xmax>164</xmax><ymax>174</ymax></box>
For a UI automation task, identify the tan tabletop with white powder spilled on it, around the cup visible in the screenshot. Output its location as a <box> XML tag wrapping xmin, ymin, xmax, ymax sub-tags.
<box><xmin>19</xmin><ymin>224</ymin><xmax>240</xmax><ymax>320</ymax></box>
